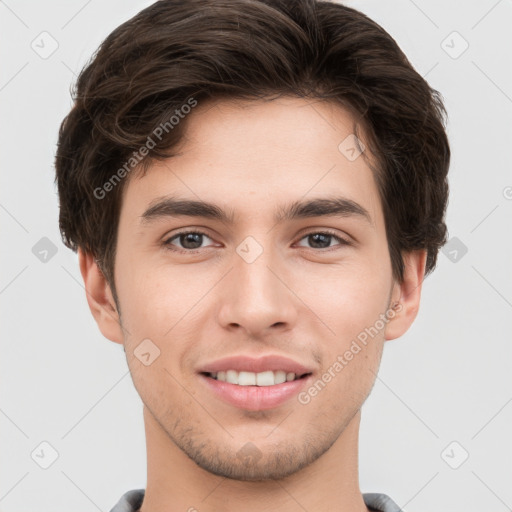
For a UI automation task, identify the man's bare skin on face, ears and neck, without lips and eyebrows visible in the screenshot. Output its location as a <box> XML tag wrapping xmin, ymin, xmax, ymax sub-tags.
<box><xmin>79</xmin><ymin>97</ymin><xmax>426</xmax><ymax>512</ymax></box>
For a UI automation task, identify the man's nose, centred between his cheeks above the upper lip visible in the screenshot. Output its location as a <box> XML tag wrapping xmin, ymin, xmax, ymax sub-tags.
<box><xmin>218</xmin><ymin>242</ymin><xmax>300</xmax><ymax>338</ymax></box>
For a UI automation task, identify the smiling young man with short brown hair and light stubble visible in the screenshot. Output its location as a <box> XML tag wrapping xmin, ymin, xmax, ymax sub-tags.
<box><xmin>56</xmin><ymin>0</ymin><xmax>450</xmax><ymax>512</ymax></box>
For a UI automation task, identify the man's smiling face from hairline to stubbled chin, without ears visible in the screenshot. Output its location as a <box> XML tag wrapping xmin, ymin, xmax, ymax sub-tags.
<box><xmin>111</xmin><ymin>97</ymin><xmax>398</xmax><ymax>480</ymax></box>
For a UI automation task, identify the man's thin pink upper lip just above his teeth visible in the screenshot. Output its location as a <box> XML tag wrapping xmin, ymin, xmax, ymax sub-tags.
<box><xmin>199</xmin><ymin>354</ymin><xmax>312</xmax><ymax>375</ymax></box>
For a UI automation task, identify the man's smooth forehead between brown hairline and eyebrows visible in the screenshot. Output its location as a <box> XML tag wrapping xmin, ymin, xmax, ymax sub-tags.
<box><xmin>123</xmin><ymin>97</ymin><xmax>380</xmax><ymax>229</ymax></box>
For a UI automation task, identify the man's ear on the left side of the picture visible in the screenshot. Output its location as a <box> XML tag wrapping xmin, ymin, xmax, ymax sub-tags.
<box><xmin>78</xmin><ymin>249</ymin><xmax>124</xmax><ymax>344</ymax></box>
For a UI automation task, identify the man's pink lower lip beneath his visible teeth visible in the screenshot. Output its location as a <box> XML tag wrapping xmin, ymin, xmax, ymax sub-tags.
<box><xmin>199</xmin><ymin>374</ymin><xmax>311</xmax><ymax>411</ymax></box>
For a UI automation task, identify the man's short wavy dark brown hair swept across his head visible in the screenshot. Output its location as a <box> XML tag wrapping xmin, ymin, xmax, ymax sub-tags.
<box><xmin>56</xmin><ymin>0</ymin><xmax>450</xmax><ymax>301</ymax></box>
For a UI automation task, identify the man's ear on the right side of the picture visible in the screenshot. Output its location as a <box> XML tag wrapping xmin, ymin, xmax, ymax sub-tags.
<box><xmin>384</xmin><ymin>249</ymin><xmax>427</xmax><ymax>340</ymax></box>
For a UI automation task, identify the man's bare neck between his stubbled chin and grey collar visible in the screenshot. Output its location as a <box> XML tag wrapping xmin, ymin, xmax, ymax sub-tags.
<box><xmin>140</xmin><ymin>407</ymin><xmax>368</xmax><ymax>512</ymax></box>
